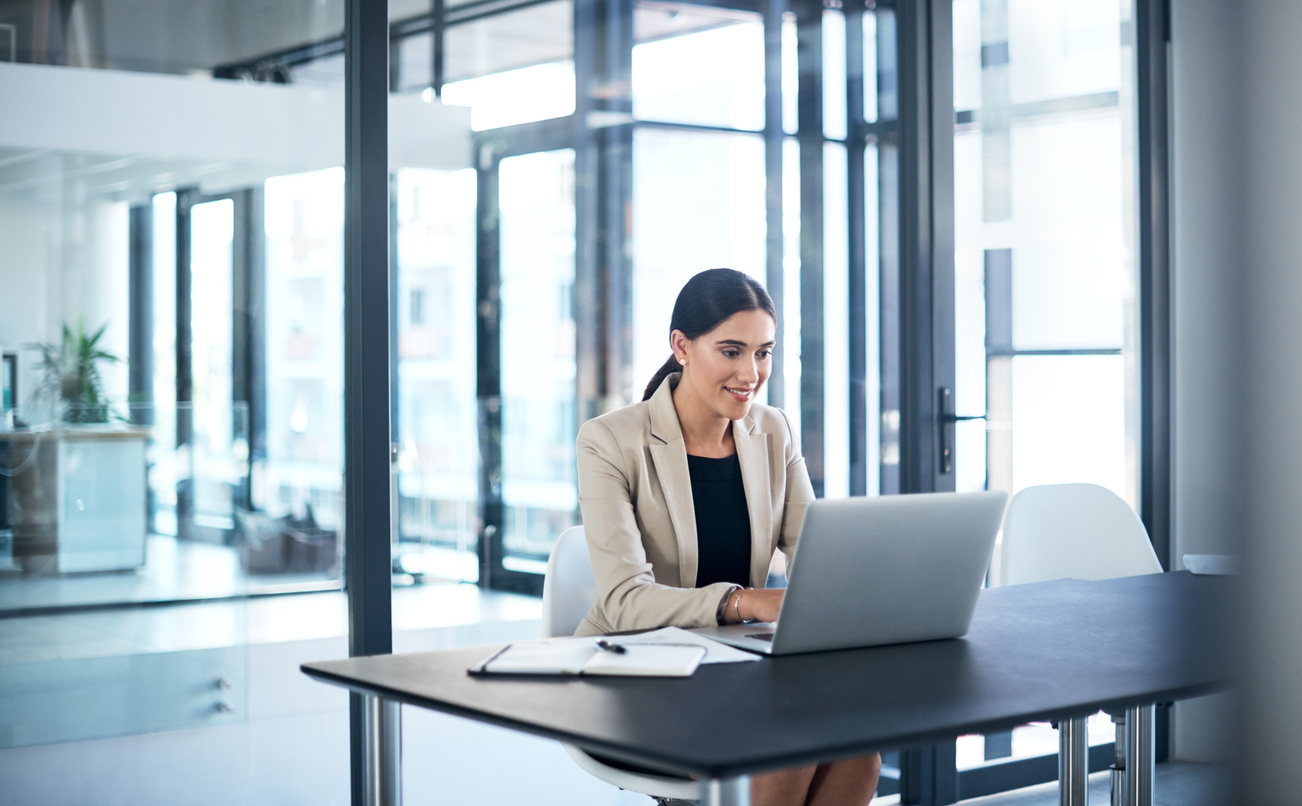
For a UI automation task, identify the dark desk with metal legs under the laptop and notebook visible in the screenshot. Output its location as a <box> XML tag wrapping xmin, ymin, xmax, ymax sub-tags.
<box><xmin>302</xmin><ymin>573</ymin><xmax>1230</xmax><ymax>802</ymax></box>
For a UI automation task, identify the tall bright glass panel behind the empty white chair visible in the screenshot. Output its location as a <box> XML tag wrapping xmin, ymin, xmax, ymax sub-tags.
<box><xmin>953</xmin><ymin>0</ymin><xmax>1139</xmax><ymax>781</ymax></box>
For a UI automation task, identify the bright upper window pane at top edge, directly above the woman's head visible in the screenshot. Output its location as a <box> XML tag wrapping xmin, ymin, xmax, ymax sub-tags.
<box><xmin>633</xmin><ymin>3</ymin><xmax>764</xmax><ymax>130</ymax></box>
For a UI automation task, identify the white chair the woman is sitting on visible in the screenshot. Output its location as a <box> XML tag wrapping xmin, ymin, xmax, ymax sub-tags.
<box><xmin>543</xmin><ymin>526</ymin><xmax>699</xmax><ymax>801</ymax></box>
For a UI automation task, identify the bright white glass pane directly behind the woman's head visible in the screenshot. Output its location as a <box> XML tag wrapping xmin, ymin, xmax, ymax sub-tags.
<box><xmin>631</xmin><ymin>129</ymin><xmax>760</xmax><ymax>400</ymax></box>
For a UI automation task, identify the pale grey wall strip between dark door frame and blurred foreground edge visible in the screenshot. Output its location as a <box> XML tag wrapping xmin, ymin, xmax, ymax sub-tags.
<box><xmin>1172</xmin><ymin>0</ymin><xmax>1245</xmax><ymax>762</ymax></box>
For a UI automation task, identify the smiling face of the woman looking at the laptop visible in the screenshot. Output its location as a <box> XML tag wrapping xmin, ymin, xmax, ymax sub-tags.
<box><xmin>669</xmin><ymin>310</ymin><xmax>776</xmax><ymax>419</ymax></box>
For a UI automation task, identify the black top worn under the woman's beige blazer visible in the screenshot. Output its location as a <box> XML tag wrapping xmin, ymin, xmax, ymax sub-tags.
<box><xmin>687</xmin><ymin>453</ymin><xmax>750</xmax><ymax>587</ymax></box>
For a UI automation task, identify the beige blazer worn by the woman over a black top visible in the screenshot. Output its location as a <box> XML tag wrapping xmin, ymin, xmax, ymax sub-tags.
<box><xmin>575</xmin><ymin>372</ymin><xmax>814</xmax><ymax>635</ymax></box>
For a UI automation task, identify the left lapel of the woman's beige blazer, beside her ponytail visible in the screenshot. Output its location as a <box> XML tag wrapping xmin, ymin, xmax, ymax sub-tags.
<box><xmin>648</xmin><ymin>374</ymin><xmax>697</xmax><ymax>587</ymax></box>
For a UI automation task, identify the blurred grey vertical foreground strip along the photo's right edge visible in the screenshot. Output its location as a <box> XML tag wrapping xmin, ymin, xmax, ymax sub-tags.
<box><xmin>1234</xmin><ymin>0</ymin><xmax>1302</xmax><ymax>803</ymax></box>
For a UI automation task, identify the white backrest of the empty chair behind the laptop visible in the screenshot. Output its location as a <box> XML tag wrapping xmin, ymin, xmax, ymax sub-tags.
<box><xmin>1000</xmin><ymin>484</ymin><xmax>1161</xmax><ymax>585</ymax></box>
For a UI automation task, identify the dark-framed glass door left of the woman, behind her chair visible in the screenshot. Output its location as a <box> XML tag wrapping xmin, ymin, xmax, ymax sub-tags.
<box><xmin>475</xmin><ymin>138</ymin><xmax>578</xmax><ymax>594</ymax></box>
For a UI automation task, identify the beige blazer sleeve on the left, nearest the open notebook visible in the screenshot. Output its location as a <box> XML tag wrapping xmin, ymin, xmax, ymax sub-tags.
<box><xmin>578</xmin><ymin>421</ymin><xmax>732</xmax><ymax>632</ymax></box>
